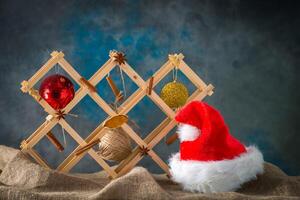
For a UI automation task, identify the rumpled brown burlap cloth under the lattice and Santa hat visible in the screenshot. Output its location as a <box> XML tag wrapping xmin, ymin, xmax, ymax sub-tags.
<box><xmin>0</xmin><ymin>145</ymin><xmax>300</xmax><ymax>200</ymax></box>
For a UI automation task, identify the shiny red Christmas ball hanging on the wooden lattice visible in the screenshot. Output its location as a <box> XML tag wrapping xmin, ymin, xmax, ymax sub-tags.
<box><xmin>39</xmin><ymin>74</ymin><xmax>75</xmax><ymax>110</ymax></box>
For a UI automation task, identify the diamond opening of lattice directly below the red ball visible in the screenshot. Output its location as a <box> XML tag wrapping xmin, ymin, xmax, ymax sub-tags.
<box><xmin>33</xmin><ymin>124</ymin><xmax>78</xmax><ymax>169</ymax></box>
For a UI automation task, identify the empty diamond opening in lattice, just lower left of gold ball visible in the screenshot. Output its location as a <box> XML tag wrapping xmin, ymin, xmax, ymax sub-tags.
<box><xmin>128</xmin><ymin>96</ymin><xmax>166</xmax><ymax>138</ymax></box>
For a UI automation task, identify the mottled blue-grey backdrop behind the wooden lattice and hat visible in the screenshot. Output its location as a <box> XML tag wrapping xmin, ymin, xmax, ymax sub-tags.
<box><xmin>0</xmin><ymin>0</ymin><xmax>300</xmax><ymax>175</ymax></box>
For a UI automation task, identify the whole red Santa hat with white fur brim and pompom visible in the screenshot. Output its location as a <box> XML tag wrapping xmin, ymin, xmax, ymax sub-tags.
<box><xmin>169</xmin><ymin>101</ymin><xmax>264</xmax><ymax>192</ymax></box>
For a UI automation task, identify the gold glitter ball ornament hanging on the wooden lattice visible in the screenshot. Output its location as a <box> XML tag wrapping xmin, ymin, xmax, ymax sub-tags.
<box><xmin>160</xmin><ymin>81</ymin><xmax>189</xmax><ymax>109</ymax></box>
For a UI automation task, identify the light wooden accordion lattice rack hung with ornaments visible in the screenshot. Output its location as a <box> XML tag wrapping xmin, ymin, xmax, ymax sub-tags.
<box><xmin>21</xmin><ymin>51</ymin><xmax>213</xmax><ymax>178</ymax></box>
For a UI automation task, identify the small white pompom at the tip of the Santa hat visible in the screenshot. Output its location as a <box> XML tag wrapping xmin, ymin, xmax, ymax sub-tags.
<box><xmin>177</xmin><ymin>124</ymin><xmax>200</xmax><ymax>142</ymax></box>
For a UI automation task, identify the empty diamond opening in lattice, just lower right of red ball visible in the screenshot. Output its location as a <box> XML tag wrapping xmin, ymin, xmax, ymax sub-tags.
<box><xmin>66</xmin><ymin>95</ymin><xmax>108</xmax><ymax>139</ymax></box>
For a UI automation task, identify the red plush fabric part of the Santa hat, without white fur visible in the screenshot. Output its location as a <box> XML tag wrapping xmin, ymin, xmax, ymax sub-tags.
<box><xmin>175</xmin><ymin>101</ymin><xmax>246</xmax><ymax>161</ymax></box>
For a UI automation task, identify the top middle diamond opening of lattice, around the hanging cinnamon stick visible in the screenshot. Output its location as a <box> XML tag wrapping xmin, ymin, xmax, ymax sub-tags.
<box><xmin>96</xmin><ymin>66</ymin><xmax>138</xmax><ymax>104</ymax></box>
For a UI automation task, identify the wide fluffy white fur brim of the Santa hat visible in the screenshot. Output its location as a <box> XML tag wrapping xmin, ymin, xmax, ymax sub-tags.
<box><xmin>169</xmin><ymin>146</ymin><xmax>264</xmax><ymax>193</ymax></box>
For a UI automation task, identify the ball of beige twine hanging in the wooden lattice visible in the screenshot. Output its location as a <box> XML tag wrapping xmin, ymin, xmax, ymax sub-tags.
<box><xmin>98</xmin><ymin>128</ymin><xmax>132</xmax><ymax>162</ymax></box>
